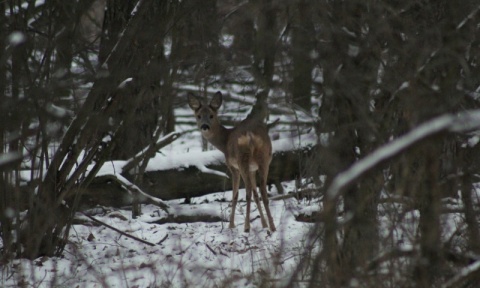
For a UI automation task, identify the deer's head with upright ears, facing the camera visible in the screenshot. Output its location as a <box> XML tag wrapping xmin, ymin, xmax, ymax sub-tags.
<box><xmin>188</xmin><ymin>91</ymin><xmax>222</xmax><ymax>139</ymax></box>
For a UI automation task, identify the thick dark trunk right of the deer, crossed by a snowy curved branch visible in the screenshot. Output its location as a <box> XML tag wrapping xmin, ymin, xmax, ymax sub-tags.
<box><xmin>312</xmin><ymin>1</ymin><xmax>381</xmax><ymax>286</ymax></box>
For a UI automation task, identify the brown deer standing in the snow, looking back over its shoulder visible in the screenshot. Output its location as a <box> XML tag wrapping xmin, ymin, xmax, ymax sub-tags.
<box><xmin>188</xmin><ymin>92</ymin><xmax>275</xmax><ymax>232</ymax></box>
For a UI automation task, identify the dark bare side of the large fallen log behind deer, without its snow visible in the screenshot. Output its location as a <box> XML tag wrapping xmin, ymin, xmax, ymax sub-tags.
<box><xmin>82</xmin><ymin>147</ymin><xmax>315</xmax><ymax>207</ymax></box>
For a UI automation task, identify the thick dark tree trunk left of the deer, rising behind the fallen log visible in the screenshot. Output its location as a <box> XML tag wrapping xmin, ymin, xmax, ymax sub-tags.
<box><xmin>103</xmin><ymin>1</ymin><xmax>165</xmax><ymax>159</ymax></box>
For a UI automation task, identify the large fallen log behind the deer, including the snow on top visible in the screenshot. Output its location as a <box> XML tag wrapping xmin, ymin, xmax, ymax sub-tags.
<box><xmin>82</xmin><ymin>134</ymin><xmax>316</xmax><ymax>207</ymax></box>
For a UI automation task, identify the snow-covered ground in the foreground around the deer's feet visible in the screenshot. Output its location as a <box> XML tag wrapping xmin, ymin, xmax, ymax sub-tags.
<box><xmin>0</xmin><ymin>183</ymin><xmax>318</xmax><ymax>287</ymax></box>
